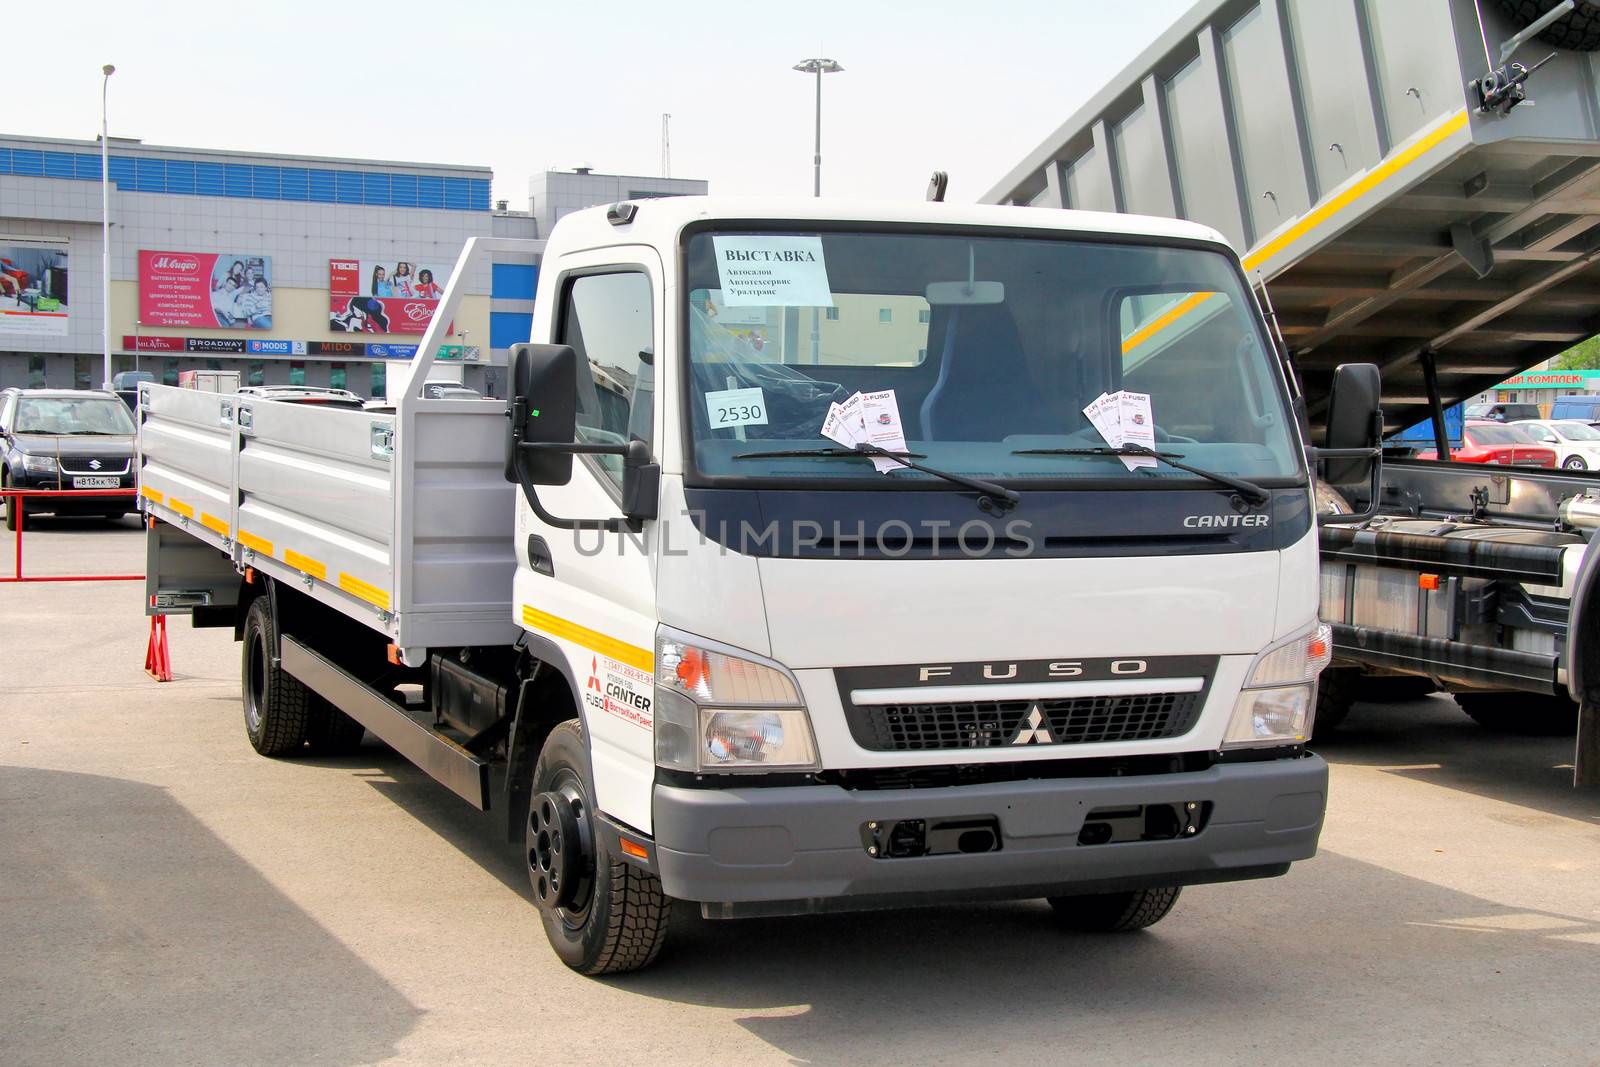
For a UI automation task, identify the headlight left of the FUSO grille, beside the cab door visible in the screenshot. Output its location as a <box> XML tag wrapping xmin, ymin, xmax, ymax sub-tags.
<box><xmin>654</xmin><ymin>627</ymin><xmax>821</xmax><ymax>773</ymax></box>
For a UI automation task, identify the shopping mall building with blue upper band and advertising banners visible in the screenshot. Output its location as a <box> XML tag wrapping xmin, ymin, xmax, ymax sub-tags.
<box><xmin>0</xmin><ymin>134</ymin><xmax>706</xmax><ymax>395</ymax></box>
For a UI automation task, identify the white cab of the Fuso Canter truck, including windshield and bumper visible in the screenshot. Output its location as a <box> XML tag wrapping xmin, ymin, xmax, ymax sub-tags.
<box><xmin>512</xmin><ymin>198</ymin><xmax>1350</xmax><ymax>966</ymax></box>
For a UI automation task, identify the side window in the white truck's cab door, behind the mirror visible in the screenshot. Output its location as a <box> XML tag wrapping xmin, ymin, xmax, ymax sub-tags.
<box><xmin>560</xmin><ymin>270</ymin><xmax>656</xmax><ymax>486</ymax></box>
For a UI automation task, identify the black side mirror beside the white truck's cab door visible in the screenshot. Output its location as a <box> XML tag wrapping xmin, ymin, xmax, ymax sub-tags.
<box><xmin>506</xmin><ymin>344</ymin><xmax>578</xmax><ymax>485</ymax></box>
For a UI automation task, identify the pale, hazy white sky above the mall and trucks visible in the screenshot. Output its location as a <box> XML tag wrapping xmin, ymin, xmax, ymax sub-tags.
<box><xmin>9</xmin><ymin>0</ymin><xmax>1192</xmax><ymax>206</ymax></box>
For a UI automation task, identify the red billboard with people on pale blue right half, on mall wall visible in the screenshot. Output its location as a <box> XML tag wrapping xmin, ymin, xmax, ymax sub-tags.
<box><xmin>139</xmin><ymin>250</ymin><xmax>272</xmax><ymax>330</ymax></box>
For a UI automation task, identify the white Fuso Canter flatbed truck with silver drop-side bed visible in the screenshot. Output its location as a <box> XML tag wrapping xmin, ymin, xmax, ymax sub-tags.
<box><xmin>139</xmin><ymin>198</ymin><xmax>1378</xmax><ymax>974</ymax></box>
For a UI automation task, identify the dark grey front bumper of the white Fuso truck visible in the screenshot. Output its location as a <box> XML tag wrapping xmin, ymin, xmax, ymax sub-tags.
<box><xmin>654</xmin><ymin>755</ymin><xmax>1328</xmax><ymax>917</ymax></box>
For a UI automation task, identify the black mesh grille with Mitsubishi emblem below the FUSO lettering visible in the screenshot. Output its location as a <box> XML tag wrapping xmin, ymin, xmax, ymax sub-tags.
<box><xmin>846</xmin><ymin>693</ymin><xmax>1202</xmax><ymax>752</ymax></box>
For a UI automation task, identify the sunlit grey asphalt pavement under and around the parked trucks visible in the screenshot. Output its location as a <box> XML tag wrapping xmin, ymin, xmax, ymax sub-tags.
<box><xmin>0</xmin><ymin>518</ymin><xmax>1600</xmax><ymax>1067</ymax></box>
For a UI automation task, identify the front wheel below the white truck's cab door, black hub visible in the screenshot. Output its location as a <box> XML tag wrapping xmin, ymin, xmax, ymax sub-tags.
<box><xmin>526</xmin><ymin>718</ymin><xmax>670</xmax><ymax>974</ymax></box>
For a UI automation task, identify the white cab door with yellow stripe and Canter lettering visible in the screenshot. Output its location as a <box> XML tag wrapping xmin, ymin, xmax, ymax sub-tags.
<box><xmin>514</xmin><ymin>248</ymin><xmax>666</xmax><ymax>832</ymax></box>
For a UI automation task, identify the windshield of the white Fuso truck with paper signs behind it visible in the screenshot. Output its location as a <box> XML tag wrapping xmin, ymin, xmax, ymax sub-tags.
<box><xmin>685</xmin><ymin>229</ymin><xmax>1302</xmax><ymax>488</ymax></box>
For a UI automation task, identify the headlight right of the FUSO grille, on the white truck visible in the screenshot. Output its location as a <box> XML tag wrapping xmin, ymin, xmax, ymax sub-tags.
<box><xmin>1222</xmin><ymin>622</ymin><xmax>1333</xmax><ymax>749</ymax></box>
